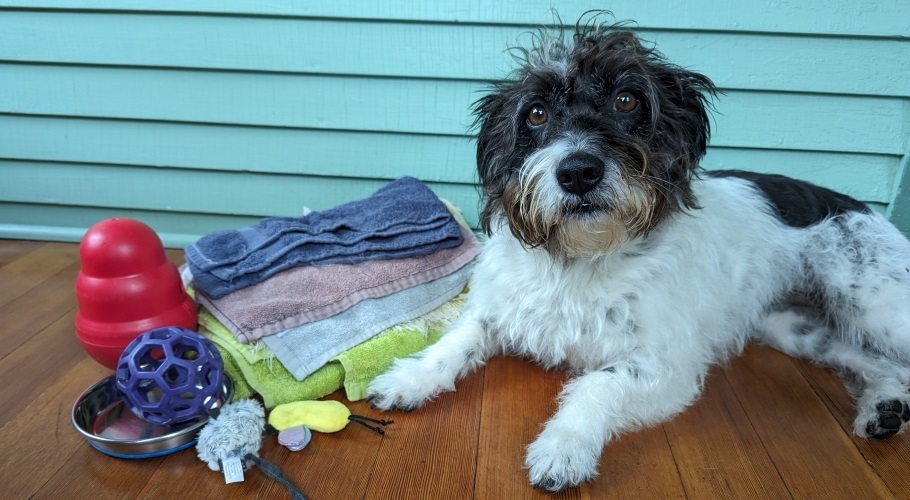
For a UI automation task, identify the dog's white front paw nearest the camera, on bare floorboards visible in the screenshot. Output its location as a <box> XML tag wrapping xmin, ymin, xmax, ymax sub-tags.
<box><xmin>525</xmin><ymin>427</ymin><xmax>603</xmax><ymax>492</ymax></box>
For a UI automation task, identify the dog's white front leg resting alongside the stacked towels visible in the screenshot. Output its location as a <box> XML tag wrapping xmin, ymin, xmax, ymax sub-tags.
<box><xmin>367</xmin><ymin>313</ymin><xmax>492</xmax><ymax>410</ymax></box>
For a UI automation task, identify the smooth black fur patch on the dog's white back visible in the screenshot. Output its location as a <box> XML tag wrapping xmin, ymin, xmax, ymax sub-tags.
<box><xmin>707</xmin><ymin>170</ymin><xmax>870</xmax><ymax>227</ymax></box>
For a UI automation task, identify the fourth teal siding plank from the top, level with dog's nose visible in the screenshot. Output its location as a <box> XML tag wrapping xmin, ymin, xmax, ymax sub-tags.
<box><xmin>0</xmin><ymin>115</ymin><xmax>902</xmax><ymax>203</ymax></box>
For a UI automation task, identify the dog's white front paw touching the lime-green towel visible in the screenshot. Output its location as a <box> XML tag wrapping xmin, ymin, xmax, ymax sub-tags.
<box><xmin>367</xmin><ymin>358</ymin><xmax>455</xmax><ymax>411</ymax></box>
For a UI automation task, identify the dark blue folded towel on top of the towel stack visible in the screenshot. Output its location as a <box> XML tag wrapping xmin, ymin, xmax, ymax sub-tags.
<box><xmin>186</xmin><ymin>177</ymin><xmax>462</xmax><ymax>298</ymax></box>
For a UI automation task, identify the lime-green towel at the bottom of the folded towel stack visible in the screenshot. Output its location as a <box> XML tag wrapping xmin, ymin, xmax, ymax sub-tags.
<box><xmin>199</xmin><ymin>290</ymin><xmax>467</xmax><ymax>408</ymax></box>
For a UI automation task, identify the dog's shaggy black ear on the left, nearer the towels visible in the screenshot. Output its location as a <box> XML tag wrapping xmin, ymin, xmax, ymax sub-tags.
<box><xmin>473</xmin><ymin>86</ymin><xmax>517</xmax><ymax>234</ymax></box>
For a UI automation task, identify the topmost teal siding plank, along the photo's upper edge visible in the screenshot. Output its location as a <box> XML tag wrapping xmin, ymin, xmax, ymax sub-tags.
<box><xmin>0</xmin><ymin>0</ymin><xmax>910</xmax><ymax>36</ymax></box>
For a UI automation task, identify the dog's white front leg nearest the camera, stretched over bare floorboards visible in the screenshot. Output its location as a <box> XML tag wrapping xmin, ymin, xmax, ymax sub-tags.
<box><xmin>525</xmin><ymin>360</ymin><xmax>707</xmax><ymax>491</ymax></box>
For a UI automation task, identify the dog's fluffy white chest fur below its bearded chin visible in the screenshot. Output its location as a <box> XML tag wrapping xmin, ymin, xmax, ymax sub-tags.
<box><xmin>472</xmin><ymin>240</ymin><xmax>640</xmax><ymax>369</ymax></box>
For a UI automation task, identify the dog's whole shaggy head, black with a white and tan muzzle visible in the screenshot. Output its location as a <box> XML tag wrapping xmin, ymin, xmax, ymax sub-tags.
<box><xmin>475</xmin><ymin>26</ymin><xmax>715</xmax><ymax>257</ymax></box>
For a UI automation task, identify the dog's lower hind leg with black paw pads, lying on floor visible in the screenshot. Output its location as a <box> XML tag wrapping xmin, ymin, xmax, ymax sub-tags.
<box><xmin>762</xmin><ymin>308</ymin><xmax>910</xmax><ymax>439</ymax></box>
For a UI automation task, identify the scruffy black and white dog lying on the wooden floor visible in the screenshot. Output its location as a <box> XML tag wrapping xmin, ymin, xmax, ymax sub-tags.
<box><xmin>369</xmin><ymin>20</ymin><xmax>910</xmax><ymax>491</ymax></box>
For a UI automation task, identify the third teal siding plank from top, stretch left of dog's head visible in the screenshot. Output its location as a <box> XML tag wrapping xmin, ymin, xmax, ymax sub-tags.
<box><xmin>0</xmin><ymin>63</ymin><xmax>484</xmax><ymax>136</ymax></box>
